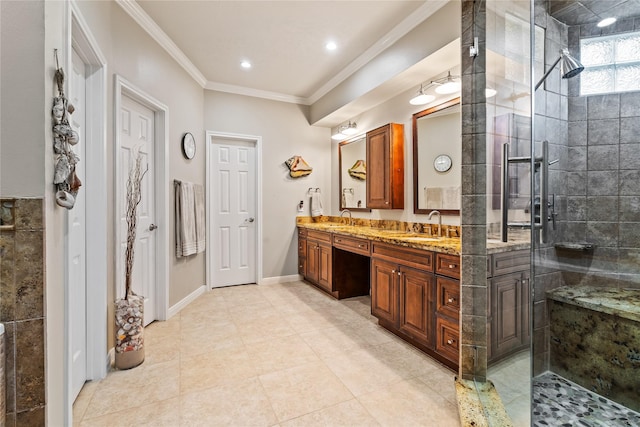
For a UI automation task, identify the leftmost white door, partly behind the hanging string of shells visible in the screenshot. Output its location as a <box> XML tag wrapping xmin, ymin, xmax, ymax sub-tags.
<box><xmin>66</xmin><ymin>50</ymin><xmax>87</xmax><ymax>400</ymax></box>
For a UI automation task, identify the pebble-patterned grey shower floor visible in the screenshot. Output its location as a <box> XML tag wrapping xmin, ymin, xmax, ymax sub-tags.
<box><xmin>531</xmin><ymin>372</ymin><xmax>640</xmax><ymax>427</ymax></box>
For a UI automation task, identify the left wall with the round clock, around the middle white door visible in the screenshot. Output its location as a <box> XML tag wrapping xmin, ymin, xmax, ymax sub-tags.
<box><xmin>78</xmin><ymin>2</ymin><xmax>205</xmax><ymax>306</ymax></box>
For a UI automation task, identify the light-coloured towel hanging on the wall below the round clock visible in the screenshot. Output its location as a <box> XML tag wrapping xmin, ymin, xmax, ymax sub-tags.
<box><xmin>175</xmin><ymin>182</ymin><xmax>198</xmax><ymax>258</ymax></box>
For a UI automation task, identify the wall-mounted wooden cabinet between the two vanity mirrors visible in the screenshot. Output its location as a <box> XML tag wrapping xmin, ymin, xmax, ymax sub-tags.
<box><xmin>367</xmin><ymin>123</ymin><xmax>404</xmax><ymax>209</ymax></box>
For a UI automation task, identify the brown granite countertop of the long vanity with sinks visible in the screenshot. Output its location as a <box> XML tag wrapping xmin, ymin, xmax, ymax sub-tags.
<box><xmin>297</xmin><ymin>221</ymin><xmax>529</xmax><ymax>255</ymax></box>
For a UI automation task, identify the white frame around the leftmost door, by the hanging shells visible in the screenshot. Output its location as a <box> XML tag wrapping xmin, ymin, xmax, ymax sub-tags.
<box><xmin>63</xmin><ymin>2</ymin><xmax>109</xmax><ymax>421</ymax></box>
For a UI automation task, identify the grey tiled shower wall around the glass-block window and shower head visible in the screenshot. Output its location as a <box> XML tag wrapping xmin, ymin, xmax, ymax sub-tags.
<box><xmin>533</xmin><ymin>0</ymin><xmax>640</xmax><ymax>375</ymax></box>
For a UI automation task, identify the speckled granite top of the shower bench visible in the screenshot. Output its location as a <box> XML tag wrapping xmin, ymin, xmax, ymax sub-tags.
<box><xmin>547</xmin><ymin>286</ymin><xmax>640</xmax><ymax>322</ymax></box>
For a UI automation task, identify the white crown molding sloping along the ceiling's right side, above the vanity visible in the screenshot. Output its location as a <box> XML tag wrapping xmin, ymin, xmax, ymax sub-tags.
<box><xmin>306</xmin><ymin>0</ymin><xmax>448</xmax><ymax>105</ymax></box>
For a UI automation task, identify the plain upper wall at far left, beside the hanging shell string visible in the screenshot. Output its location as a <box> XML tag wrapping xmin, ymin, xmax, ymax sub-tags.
<box><xmin>0</xmin><ymin>1</ymin><xmax>45</xmax><ymax>197</ymax></box>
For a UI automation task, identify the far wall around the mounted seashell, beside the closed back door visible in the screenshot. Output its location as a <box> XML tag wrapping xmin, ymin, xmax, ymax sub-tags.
<box><xmin>204</xmin><ymin>91</ymin><xmax>330</xmax><ymax>278</ymax></box>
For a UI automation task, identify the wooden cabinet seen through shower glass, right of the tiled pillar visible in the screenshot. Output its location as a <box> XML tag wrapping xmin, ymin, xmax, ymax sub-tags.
<box><xmin>488</xmin><ymin>250</ymin><xmax>531</xmax><ymax>363</ymax></box>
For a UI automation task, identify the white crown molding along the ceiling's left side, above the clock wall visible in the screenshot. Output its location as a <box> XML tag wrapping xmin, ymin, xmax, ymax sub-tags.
<box><xmin>115</xmin><ymin>0</ymin><xmax>207</xmax><ymax>88</ymax></box>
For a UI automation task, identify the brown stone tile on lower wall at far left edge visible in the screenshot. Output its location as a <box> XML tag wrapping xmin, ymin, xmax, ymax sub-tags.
<box><xmin>0</xmin><ymin>199</ymin><xmax>45</xmax><ymax>427</ymax></box>
